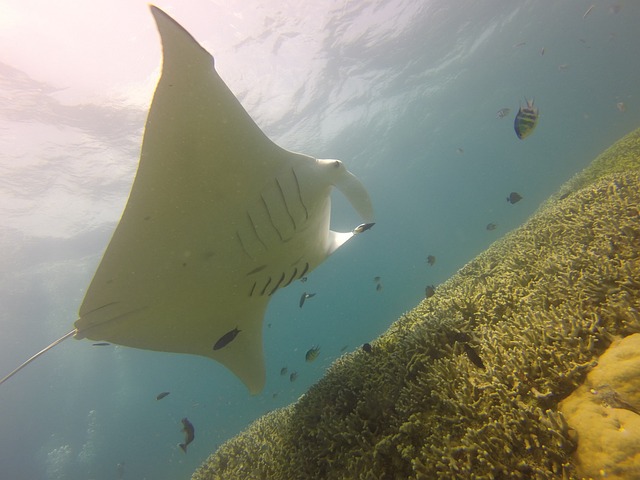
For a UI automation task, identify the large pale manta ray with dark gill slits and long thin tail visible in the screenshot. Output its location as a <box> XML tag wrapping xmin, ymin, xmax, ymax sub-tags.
<box><xmin>0</xmin><ymin>6</ymin><xmax>373</xmax><ymax>394</ymax></box>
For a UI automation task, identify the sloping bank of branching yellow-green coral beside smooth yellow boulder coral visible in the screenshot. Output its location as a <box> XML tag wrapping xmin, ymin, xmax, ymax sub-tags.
<box><xmin>192</xmin><ymin>125</ymin><xmax>640</xmax><ymax>480</ymax></box>
